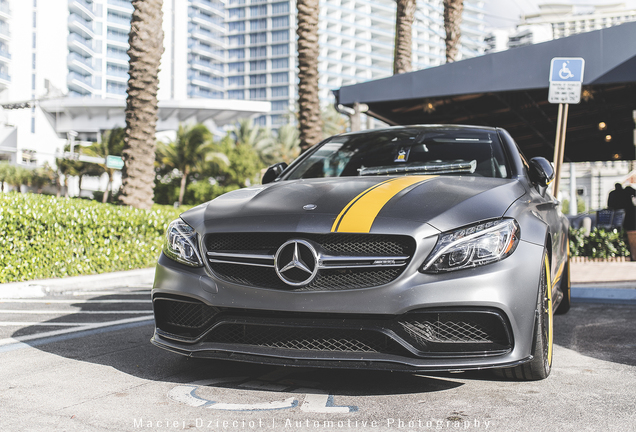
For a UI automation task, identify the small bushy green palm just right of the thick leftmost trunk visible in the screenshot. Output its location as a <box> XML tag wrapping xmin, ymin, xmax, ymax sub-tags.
<box><xmin>158</xmin><ymin>123</ymin><xmax>229</xmax><ymax>205</ymax></box>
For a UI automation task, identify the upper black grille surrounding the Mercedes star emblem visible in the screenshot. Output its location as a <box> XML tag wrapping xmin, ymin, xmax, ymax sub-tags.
<box><xmin>204</xmin><ymin>233</ymin><xmax>415</xmax><ymax>291</ymax></box>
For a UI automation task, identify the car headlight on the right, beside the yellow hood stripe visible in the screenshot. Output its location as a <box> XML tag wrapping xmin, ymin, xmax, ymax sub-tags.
<box><xmin>420</xmin><ymin>219</ymin><xmax>520</xmax><ymax>273</ymax></box>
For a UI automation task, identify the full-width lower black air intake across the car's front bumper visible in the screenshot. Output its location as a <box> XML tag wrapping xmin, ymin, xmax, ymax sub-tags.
<box><xmin>154</xmin><ymin>297</ymin><xmax>512</xmax><ymax>357</ymax></box>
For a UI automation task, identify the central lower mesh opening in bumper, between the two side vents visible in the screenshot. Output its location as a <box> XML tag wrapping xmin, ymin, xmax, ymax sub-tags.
<box><xmin>206</xmin><ymin>324</ymin><xmax>404</xmax><ymax>354</ymax></box>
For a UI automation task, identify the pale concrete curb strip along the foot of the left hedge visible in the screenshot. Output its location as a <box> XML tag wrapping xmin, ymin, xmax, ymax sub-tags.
<box><xmin>0</xmin><ymin>267</ymin><xmax>155</xmax><ymax>299</ymax></box>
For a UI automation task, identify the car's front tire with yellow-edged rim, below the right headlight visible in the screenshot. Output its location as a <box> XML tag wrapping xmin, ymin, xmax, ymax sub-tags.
<box><xmin>495</xmin><ymin>252</ymin><xmax>552</xmax><ymax>381</ymax></box>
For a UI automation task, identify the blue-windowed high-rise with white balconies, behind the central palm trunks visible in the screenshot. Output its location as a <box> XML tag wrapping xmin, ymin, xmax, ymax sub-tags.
<box><xmin>227</xmin><ymin>0</ymin><xmax>486</xmax><ymax>127</ymax></box>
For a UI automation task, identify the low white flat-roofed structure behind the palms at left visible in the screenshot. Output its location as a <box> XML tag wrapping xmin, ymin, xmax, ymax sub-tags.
<box><xmin>39</xmin><ymin>98</ymin><xmax>271</xmax><ymax>137</ymax></box>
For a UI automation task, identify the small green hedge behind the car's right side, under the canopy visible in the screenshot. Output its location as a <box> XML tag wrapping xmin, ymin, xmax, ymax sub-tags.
<box><xmin>570</xmin><ymin>228</ymin><xmax>629</xmax><ymax>258</ymax></box>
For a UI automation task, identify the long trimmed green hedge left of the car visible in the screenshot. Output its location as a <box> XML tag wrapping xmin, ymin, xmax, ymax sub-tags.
<box><xmin>0</xmin><ymin>193</ymin><xmax>183</xmax><ymax>283</ymax></box>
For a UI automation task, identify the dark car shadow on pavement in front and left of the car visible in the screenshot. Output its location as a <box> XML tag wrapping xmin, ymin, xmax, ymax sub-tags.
<box><xmin>12</xmin><ymin>292</ymin><xmax>468</xmax><ymax>396</ymax></box>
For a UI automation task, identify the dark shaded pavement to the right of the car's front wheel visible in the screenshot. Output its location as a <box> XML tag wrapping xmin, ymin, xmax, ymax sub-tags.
<box><xmin>554</xmin><ymin>300</ymin><xmax>636</xmax><ymax>366</ymax></box>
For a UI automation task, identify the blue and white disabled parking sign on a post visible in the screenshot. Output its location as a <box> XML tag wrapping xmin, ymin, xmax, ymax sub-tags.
<box><xmin>548</xmin><ymin>57</ymin><xmax>585</xmax><ymax>104</ymax></box>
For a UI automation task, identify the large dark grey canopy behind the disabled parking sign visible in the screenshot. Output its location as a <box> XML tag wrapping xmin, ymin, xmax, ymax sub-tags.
<box><xmin>334</xmin><ymin>22</ymin><xmax>636</xmax><ymax>161</ymax></box>
